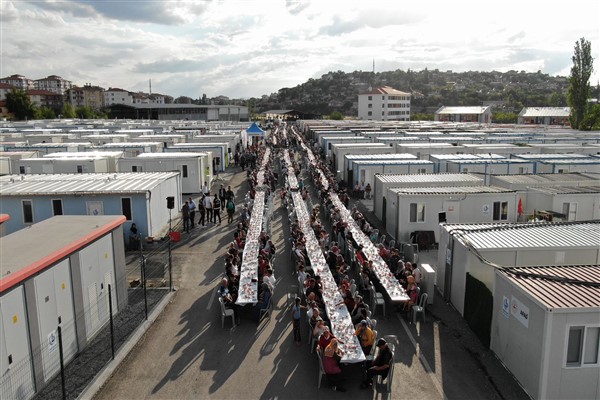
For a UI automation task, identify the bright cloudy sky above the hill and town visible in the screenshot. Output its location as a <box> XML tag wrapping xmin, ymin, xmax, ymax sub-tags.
<box><xmin>0</xmin><ymin>0</ymin><xmax>600</xmax><ymax>98</ymax></box>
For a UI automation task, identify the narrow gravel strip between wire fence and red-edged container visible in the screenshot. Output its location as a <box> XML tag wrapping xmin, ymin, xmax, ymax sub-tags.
<box><xmin>34</xmin><ymin>288</ymin><xmax>169</xmax><ymax>400</ymax></box>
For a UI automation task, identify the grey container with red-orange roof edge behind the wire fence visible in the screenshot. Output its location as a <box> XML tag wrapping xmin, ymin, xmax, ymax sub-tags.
<box><xmin>0</xmin><ymin>216</ymin><xmax>127</xmax><ymax>399</ymax></box>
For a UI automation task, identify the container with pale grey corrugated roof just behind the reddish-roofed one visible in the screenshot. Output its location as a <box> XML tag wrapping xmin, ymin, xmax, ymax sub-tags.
<box><xmin>437</xmin><ymin>221</ymin><xmax>600</xmax><ymax>315</ymax></box>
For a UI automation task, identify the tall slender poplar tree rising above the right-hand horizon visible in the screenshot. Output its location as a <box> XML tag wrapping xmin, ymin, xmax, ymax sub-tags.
<box><xmin>567</xmin><ymin>38</ymin><xmax>594</xmax><ymax>129</ymax></box>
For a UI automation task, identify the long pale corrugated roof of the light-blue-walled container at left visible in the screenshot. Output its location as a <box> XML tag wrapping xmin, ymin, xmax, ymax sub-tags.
<box><xmin>0</xmin><ymin>172</ymin><xmax>179</xmax><ymax>197</ymax></box>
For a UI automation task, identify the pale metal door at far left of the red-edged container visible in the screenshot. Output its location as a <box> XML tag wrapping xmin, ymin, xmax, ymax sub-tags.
<box><xmin>0</xmin><ymin>286</ymin><xmax>35</xmax><ymax>400</ymax></box>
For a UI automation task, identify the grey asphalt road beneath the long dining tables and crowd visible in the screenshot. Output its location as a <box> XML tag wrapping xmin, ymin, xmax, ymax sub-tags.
<box><xmin>96</xmin><ymin>166</ymin><xmax>528</xmax><ymax>400</ymax></box>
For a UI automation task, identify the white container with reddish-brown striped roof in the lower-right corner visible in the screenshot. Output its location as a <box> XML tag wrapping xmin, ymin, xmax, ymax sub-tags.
<box><xmin>490</xmin><ymin>264</ymin><xmax>600</xmax><ymax>400</ymax></box>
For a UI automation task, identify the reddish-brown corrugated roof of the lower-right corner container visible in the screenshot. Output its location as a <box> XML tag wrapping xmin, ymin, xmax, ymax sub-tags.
<box><xmin>498</xmin><ymin>265</ymin><xmax>600</xmax><ymax>310</ymax></box>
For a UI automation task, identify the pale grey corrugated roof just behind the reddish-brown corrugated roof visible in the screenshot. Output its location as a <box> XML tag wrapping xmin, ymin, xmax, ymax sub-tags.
<box><xmin>446</xmin><ymin>220</ymin><xmax>600</xmax><ymax>250</ymax></box>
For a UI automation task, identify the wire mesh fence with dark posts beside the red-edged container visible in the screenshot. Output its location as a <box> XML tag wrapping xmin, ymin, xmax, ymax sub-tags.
<box><xmin>27</xmin><ymin>240</ymin><xmax>173</xmax><ymax>399</ymax></box>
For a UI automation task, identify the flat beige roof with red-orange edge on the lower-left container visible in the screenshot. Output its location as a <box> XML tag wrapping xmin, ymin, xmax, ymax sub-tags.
<box><xmin>0</xmin><ymin>215</ymin><xmax>125</xmax><ymax>292</ymax></box>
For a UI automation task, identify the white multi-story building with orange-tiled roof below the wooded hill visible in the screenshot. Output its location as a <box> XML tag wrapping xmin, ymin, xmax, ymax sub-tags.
<box><xmin>358</xmin><ymin>86</ymin><xmax>411</xmax><ymax>121</ymax></box>
